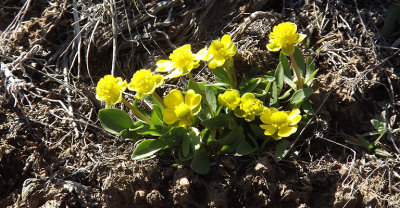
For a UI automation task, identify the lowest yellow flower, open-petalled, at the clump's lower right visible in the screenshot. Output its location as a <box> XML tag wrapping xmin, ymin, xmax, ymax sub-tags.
<box><xmin>260</xmin><ymin>108</ymin><xmax>301</xmax><ymax>140</ymax></box>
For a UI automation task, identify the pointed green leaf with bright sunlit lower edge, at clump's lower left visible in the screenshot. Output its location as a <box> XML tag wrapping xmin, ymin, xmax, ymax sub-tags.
<box><xmin>131</xmin><ymin>139</ymin><xmax>167</xmax><ymax>160</ymax></box>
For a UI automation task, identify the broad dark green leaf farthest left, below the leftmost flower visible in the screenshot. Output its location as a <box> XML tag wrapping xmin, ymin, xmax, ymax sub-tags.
<box><xmin>99</xmin><ymin>108</ymin><xmax>133</xmax><ymax>135</ymax></box>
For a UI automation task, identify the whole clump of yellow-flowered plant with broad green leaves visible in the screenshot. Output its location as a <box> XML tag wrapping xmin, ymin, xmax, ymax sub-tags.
<box><xmin>96</xmin><ymin>22</ymin><xmax>317</xmax><ymax>174</ymax></box>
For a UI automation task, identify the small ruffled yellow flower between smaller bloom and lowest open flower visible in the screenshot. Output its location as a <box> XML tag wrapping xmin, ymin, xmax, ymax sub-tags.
<box><xmin>235</xmin><ymin>93</ymin><xmax>266</xmax><ymax>122</ymax></box>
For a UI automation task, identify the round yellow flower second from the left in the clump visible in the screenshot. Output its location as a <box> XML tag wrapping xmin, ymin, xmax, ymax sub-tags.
<box><xmin>128</xmin><ymin>69</ymin><xmax>164</xmax><ymax>99</ymax></box>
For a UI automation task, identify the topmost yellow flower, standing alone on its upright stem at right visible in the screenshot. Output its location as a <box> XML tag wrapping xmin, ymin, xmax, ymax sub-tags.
<box><xmin>267</xmin><ymin>22</ymin><xmax>306</xmax><ymax>56</ymax></box>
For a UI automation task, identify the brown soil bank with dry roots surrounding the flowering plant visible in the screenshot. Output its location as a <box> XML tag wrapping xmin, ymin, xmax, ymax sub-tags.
<box><xmin>0</xmin><ymin>0</ymin><xmax>400</xmax><ymax>207</ymax></box>
